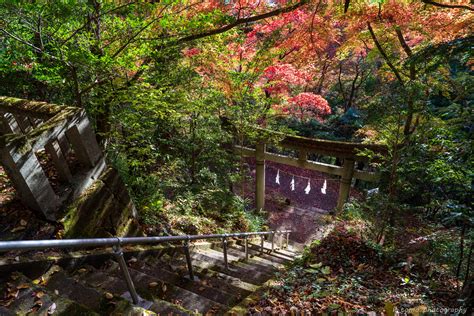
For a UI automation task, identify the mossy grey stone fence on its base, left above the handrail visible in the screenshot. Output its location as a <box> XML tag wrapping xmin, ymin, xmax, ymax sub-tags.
<box><xmin>0</xmin><ymin>97</ymin><xmax>138</xmax><ymax>237</ymax></box>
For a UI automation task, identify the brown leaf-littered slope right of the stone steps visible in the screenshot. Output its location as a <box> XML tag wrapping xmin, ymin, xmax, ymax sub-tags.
<box><xmin>249</xmin><ymin>222</ymin><xmax>466</xmax><ymax>315</ymax></box>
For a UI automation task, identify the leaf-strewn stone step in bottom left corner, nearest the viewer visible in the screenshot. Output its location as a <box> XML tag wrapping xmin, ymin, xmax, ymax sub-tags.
<box><xmin>0</xmin><ymin>273</ymin><xmax>99</xmax><ymax>316</ymax></box>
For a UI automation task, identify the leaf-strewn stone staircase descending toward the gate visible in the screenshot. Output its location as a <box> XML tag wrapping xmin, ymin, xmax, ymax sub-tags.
<box><xmin>0</xmin><ymin>239</ymin><xmax>298</xmax><ymax>315</ymax></box>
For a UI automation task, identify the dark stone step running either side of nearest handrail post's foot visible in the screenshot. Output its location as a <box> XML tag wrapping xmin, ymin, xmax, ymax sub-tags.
<box><xmin>75</xmin><ymin>266</ymin><xmax>196</xmax><ymax>316</ymax></box>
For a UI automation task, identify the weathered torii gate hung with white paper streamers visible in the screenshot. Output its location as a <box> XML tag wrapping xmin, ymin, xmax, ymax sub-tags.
<box><xmin>235</xmin><ymin>130</ymin><xmax>388</xmax><ymax>212</ymax></box>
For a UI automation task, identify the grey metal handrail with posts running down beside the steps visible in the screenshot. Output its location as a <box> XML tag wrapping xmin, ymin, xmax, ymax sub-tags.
<box><xmin>0</xmin><ymin>230</ymin><xmax>291</xmax><ymax>304</ymax></box>
